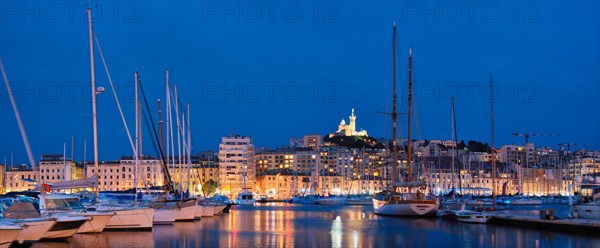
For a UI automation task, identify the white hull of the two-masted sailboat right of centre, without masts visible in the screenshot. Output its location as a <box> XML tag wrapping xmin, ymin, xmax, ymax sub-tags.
<box><xmin>373</xmin><ymin>199</ymin><xmax>439</xmax><ymax>216</ymax></box>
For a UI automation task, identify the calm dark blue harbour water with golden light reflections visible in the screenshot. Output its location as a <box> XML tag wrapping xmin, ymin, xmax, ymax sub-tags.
<box><xmin>34</xmin><ymin>203</ymin><xmax>600</xmax><ymax>248</ymax></box>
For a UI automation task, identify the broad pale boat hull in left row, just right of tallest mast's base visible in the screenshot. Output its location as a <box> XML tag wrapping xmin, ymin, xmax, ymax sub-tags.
<box><xmin>104</xmin><ymin>208</ymin><xmax>155</xmax><ymax>231</ymax></box>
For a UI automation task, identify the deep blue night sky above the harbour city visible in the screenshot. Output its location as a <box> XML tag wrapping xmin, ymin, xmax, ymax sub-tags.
<box><xmin>0</xmin><ymin>0</ymin><xmax>600</xmax><ymax>163</ymax></box>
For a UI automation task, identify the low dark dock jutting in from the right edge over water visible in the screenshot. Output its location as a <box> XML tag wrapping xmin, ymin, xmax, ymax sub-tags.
<box><xmin>491</xmin><ymin>214</ymin><xmax>600</xmax><ymax>235</ymax></box>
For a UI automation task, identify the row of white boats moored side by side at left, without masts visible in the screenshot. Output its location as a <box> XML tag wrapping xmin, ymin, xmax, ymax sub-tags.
<box><xmin>0</xmin><ymin>193</ymin><xmax>227</xmax><ymax>245</ymax></box>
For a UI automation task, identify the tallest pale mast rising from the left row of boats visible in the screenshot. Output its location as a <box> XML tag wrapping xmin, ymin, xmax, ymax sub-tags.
<box><xmin>87</xmin><ymin>6</ymin><xmax>99</xmax><ymax>192</ymax></box>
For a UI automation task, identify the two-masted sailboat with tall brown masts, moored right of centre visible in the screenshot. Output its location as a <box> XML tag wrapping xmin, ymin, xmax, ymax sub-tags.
<box><xmin>373</xmin><ymin>23</ymin><xmax>439</xmax><ymax>216</ymax></box>
